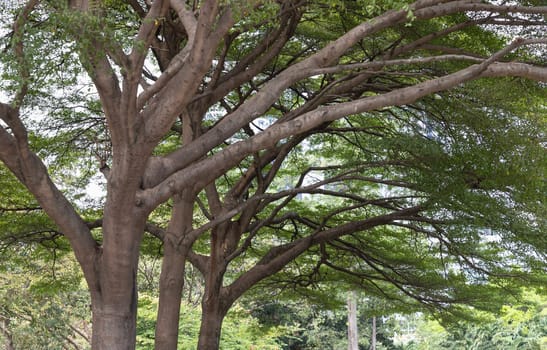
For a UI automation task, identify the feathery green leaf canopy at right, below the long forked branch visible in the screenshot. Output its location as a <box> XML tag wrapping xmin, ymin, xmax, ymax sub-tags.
<box><xmin>244</xmin><ymin>74</ymin><xmax>547</xmax><ymax>317</ymax></box>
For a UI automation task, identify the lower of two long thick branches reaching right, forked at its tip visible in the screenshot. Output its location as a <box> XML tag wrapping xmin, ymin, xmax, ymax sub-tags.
<box><xmin>143</xmin><ymin>40</ymin><xmax>547</xmax><ymax>209</ymax></box>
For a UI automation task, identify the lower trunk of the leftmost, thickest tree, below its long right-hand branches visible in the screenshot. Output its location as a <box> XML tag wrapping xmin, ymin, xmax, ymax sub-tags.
<box><xmin>88</xmin><ymin>206</ymin><xmax>146</xmax><ymax>350</ymax></box>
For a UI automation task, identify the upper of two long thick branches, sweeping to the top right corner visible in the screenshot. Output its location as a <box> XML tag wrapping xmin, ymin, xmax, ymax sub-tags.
<box><xmin>144</xmin><ymin>1</ymin><xmax>544</xmax><ymax>187</ymax></box>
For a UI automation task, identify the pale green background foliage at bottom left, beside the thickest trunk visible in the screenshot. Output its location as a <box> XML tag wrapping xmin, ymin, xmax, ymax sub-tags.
<box><xmin>0</xmin><ymin>244</ymin><xmax>91</xmax><ymax>350</ymax></box>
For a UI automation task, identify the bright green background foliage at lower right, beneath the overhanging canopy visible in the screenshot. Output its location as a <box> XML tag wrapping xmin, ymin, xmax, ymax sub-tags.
<box><xmin>249</xmin><ymin>290</ymin><xmax>547</xmax><ymax>350</ymax></box>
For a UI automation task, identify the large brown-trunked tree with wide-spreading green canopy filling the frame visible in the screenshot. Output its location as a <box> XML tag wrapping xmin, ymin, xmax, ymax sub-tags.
<box><xmin>0</xmin><ymin>0</ymin><xmax>547</xmax><ymax>350</ymax></box>
